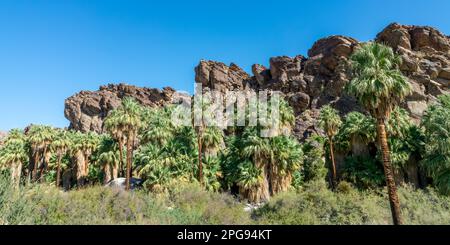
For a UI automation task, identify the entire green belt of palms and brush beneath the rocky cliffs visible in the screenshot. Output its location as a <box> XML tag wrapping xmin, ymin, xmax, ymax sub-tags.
<box><xmin>0</xmin><ymin>39</ymin><xmax>450</xmax><ymax>225</ymax></box>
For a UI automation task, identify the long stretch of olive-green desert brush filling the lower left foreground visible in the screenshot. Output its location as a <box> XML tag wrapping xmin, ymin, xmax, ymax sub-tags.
<box><xmin>0</xmin><ymin>176</ymin><xmax>250</xmax><ymax>225</ymax></box>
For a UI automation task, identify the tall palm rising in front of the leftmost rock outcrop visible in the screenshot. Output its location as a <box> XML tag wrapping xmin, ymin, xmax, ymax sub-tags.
<box><xmin>105</xmin><ymin>97</ymin><xmax>142</xmax><ymax>190</ymax></box>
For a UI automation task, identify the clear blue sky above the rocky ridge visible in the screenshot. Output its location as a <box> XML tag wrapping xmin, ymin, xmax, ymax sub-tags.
<box><xmin>0</xmin><ymin>0</ymin><xmax>450</xmax><ymax>130</ymax></box>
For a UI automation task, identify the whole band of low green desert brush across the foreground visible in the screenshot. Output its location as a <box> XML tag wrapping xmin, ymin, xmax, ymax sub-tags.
<box><xmin>0</xmin><ymin>176</ymin><xmax>450</xmax><ymax>225</ymax></box>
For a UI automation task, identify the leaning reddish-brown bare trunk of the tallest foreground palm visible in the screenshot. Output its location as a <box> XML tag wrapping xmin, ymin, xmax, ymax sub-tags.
<box><xmin>377</xmin><ymin>119</ymin><xmax>403</xmax><ymax>225</ymax></box>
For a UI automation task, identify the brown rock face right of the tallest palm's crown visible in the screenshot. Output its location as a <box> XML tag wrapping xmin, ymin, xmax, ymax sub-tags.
<box><xmin>376</xmin><ymin>23</ymin><xmax>450</xmax><ymax>122</ymax></box>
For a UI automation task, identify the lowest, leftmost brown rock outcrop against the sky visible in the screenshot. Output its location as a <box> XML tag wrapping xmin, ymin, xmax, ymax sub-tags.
<box><xmin>64</xmin><ymin>84</ymin><xmax>181</xmax><ymax>132</ymax></box>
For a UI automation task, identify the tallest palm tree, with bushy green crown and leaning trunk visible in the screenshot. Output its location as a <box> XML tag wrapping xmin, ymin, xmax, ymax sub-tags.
<box><xmin>346</xmin><ymin>43</ymin><xmax>411</xmax><ymax>225</ymax></box>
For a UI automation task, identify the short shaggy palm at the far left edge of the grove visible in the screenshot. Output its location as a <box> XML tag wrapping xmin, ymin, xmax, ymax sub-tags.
<box><xmin>0</xmin><ymin>130</ymin><xmax>28</xmax><ymax>188</ymax></box>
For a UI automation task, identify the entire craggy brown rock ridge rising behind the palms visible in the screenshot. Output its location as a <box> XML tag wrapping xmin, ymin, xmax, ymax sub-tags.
<box><xmin>65</xmin><ymin>23</ymin><xmax>450</xmax><ymax>138</ymax></box>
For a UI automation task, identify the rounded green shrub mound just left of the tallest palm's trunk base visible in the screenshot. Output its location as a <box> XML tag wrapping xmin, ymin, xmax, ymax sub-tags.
<box><xmin>251</xmin><ymin>181</ymin><xmax>390</xmax><ymax>225</ymax></box>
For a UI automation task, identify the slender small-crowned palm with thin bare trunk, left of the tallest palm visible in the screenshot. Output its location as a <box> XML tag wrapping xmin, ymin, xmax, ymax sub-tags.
<box><xmin>319</xmin><ymin>105</ymin><xmax>342</xmax><ymax>188</ymax></box>
